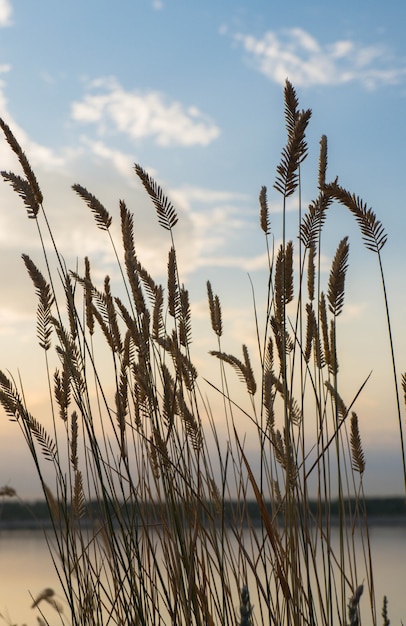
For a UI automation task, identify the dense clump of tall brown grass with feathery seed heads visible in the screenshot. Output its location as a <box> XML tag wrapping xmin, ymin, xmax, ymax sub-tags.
<box><xmin>0</xmin><ymin>81</ymin><xmax>406</xmax><ymax>626</ymax></box>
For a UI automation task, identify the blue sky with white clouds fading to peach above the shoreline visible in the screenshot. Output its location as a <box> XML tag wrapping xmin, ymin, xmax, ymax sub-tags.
<box><xmin>0</xmin><ymin>0</ymin><xmax>406</xmax><ymax>498</ymax></box>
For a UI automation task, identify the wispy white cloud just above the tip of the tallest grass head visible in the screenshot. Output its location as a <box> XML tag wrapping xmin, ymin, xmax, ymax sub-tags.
<box><xmin>234</xmin><ymin>28</ymin><xmax>406</xmax><ymax>89</ymax></box>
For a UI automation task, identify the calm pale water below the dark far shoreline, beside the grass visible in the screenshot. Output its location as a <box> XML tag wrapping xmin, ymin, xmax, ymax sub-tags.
<box><xmin>0</xmin><ymin>526</ymin><xmax>406</xmax><ymax>626</ymax></box>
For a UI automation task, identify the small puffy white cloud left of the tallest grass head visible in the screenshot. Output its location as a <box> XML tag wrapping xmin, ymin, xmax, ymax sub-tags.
<box><xmin>71</xmin><ymin>78</ymin><xmax>220</xmax><ymax>146</ymax></box>
